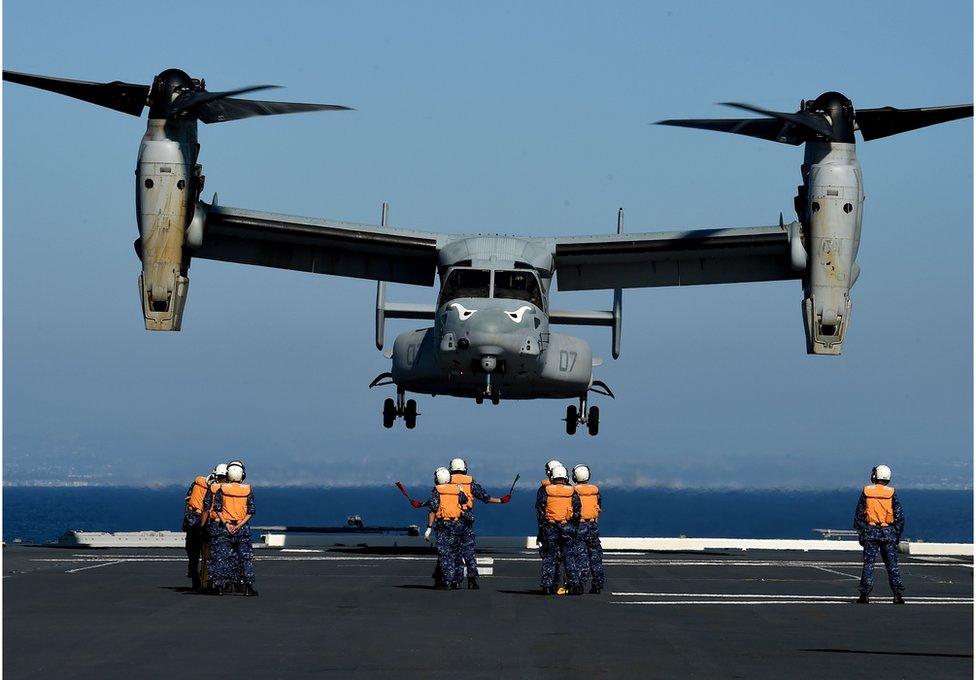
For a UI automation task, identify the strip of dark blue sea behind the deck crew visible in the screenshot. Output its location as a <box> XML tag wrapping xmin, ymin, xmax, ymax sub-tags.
<box><xmin>3</xmin><ymin>484</ymin><xmax>973</xmax><ymax>543</ymax></box>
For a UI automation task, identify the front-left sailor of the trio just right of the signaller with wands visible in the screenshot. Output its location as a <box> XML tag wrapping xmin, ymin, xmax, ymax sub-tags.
<box><xmin>535</xmin><ymin>465</ymin><xmax>583</xmax><ymax>595</ymax></box>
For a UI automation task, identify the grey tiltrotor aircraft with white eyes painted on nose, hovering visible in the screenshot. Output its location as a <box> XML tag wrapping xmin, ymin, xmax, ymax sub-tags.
<box><xmin>3</xmin><ymin>69</ymin><xmax>973</xmax><ymax>435</ymax></box>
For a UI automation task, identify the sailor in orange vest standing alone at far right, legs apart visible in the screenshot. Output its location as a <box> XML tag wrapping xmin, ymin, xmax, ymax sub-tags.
<box><xmin>854</xmin><ymin>465</ymin><xmax>905</xmax><ymax>604</ymax></box>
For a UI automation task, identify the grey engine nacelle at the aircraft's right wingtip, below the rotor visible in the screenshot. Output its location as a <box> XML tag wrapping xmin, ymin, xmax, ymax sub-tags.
<box><xmin>803</xmin><ymin>143</ymin><xmax>863</xmax><ymax>355</ymax></box>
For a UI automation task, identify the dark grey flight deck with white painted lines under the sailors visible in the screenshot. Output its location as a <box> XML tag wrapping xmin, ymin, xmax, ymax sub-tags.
<box><xmin>3</xmin><ymin>546</ymin><xmax>973</xmax><ymax>679</ymax></box>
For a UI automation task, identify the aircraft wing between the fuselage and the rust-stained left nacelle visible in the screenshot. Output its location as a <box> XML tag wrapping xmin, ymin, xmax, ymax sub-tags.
<box><xmin>190</xmin><ymin>206</ymin><xmax>442</xmax><ymax>286</ymax></box>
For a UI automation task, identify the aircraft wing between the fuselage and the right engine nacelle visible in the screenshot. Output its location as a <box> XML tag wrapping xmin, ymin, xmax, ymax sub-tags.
<box><xmin>555</xmin><ymin>220</ymin><xmax>802</xmax><ymax>290</ymax></box>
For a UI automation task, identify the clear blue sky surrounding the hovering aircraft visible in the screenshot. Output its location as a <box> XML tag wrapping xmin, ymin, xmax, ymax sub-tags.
<box><xmin>3</xmin><ymin>0</ymin><xmax>973</xmax><ymax>487</ymax></box>
